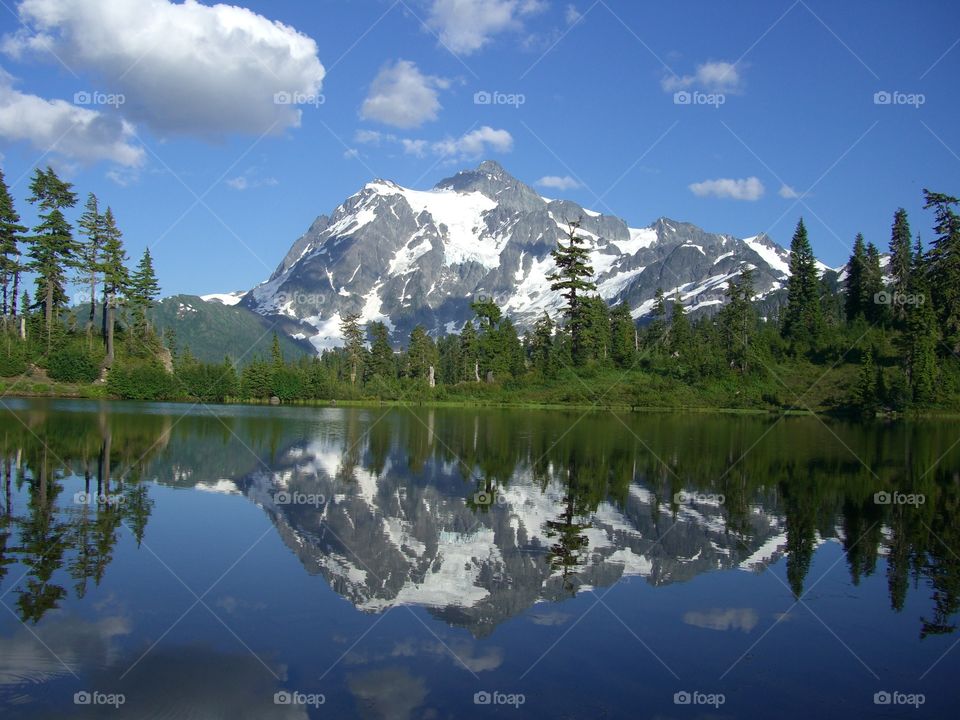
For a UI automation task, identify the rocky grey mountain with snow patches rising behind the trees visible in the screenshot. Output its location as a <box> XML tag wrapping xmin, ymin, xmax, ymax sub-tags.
<box><xmin>225</xmin><ymin>161</ymin><xmax>826</xmax><ymax>351</ymax></box>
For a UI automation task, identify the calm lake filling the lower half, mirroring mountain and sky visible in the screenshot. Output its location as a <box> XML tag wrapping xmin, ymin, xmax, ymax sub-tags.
<box><xmin>0</xmin><ymin>398</ymin><xmax>960</xmax><ymax>720</ymax></box>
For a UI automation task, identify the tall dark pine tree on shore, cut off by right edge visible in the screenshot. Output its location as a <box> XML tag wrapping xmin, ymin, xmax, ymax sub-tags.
<box><xmin>923</xmin><ymin>189</ymin><xmax>960</xmax><ymax>353</ymax></box>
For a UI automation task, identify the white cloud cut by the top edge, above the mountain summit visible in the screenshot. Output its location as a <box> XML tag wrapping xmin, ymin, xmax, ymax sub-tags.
<box><xmin>427</xmin><ymin>0</ymin><xmax>546</xmax><ymax>55</ymax></box>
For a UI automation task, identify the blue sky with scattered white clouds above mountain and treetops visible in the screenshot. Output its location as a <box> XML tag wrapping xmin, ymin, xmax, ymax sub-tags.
<box><xmin>0</xmin><ymin>0</ymin><xmax>960</xmax><ymax>295</ymax></box>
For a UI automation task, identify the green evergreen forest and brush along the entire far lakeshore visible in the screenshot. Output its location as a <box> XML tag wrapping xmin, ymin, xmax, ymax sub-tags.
<box><xmin>0</xmin><ymin>163</ymin><xmax>960</xmax><ymax>414</ymax></box>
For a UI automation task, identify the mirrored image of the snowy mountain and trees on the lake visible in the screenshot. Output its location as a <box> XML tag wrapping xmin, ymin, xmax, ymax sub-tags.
<box><xmin>0</xmin><ymin>402</ymin><xmax>960</xmax><ymax>640</ymax></box>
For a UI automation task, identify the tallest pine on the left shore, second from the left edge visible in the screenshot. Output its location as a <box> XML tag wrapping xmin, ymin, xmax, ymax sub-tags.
<box><xmin>28</xmin><ymin>167</ymin><xmax>77</xmax><ymax>348</ymax></box>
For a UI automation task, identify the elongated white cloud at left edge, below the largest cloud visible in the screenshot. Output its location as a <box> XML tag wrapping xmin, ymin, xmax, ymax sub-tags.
<box><xmin>0</xmin><ymin>69</ymin><xmax>145</xmax><ymax>167</ymax></box>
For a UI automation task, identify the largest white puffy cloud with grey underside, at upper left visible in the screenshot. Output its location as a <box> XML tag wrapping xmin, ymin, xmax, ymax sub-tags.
<box><xmin>2</xmin><ymin>0</ymin><xmax>325</xmax><ymax>138</ymax></box>
